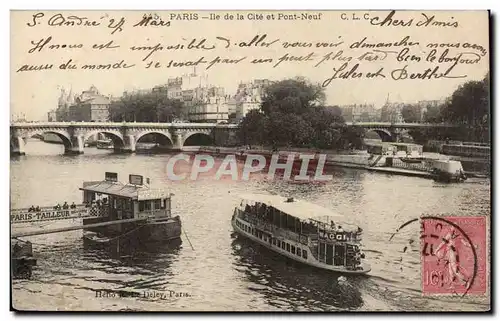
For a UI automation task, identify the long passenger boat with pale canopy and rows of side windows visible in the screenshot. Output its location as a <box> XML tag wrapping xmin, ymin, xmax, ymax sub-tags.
<box><xmin>231</xmin><ymin>194</ymin><xmax>371</xmax><ymax>274</ymax></box>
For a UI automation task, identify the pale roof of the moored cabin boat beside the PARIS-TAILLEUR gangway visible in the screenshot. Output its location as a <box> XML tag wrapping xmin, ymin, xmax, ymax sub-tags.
<box><xmin>80</xmin><ymin>181</ymin><xmax>170</xmax><ymax>201</ymax></box>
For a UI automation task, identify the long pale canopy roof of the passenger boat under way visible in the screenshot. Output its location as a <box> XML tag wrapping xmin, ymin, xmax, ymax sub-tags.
<box><xmin>241</xmin><ymin>194</ymin><xmax>344</xmax><ymax>220</ymax></box>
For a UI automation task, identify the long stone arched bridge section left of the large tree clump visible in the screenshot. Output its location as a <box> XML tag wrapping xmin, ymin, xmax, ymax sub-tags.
<box><xmin>10</xmin><ymin>122</ymin><xmax>238</xmax><ymax>155</ymax></box>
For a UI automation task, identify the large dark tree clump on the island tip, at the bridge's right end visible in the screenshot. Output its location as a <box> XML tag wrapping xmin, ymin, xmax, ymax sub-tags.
<box><xmin>239</xmin><ymin>78</ymin><xmax>364</xmax><ymax>149</ymax></box>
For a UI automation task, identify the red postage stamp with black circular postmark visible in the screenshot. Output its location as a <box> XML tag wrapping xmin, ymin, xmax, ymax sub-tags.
<box><xmin>421</xmin><ymin>216</ymin><xmax>488</xmax><ymax>295</ymax></box>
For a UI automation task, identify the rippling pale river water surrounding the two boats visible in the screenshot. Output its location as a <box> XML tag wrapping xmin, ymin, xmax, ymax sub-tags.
<box><xmin>11</xmin><ymin>140</ymin><xmax>490</xmax><ymax>311</ymax></box>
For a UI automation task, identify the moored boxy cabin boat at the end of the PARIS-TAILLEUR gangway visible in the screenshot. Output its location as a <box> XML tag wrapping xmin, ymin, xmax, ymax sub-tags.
<box><xmin>80</xmin><ymin>172</ymin><xmax>181</xmax><ymax>245</ymax></box>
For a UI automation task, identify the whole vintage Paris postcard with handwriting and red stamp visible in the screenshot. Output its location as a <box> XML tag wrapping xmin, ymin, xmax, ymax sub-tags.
<box><xmin>9</xmin><ymin>10</ymin><xmax>492</xmax><ymax>312</ymax></box>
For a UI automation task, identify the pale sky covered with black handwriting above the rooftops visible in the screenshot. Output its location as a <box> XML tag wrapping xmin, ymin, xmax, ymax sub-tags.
<box><xmin>10</xmin><ymin>11</ymin><xmax>489</xmax><ymax>120</ymax></box>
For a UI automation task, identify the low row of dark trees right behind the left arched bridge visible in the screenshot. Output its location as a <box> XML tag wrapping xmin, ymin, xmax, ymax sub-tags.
<box><xmin>109</xmin><ymin>92</ymin><xmax>187</xmax><ymax>122</ymax></box>
